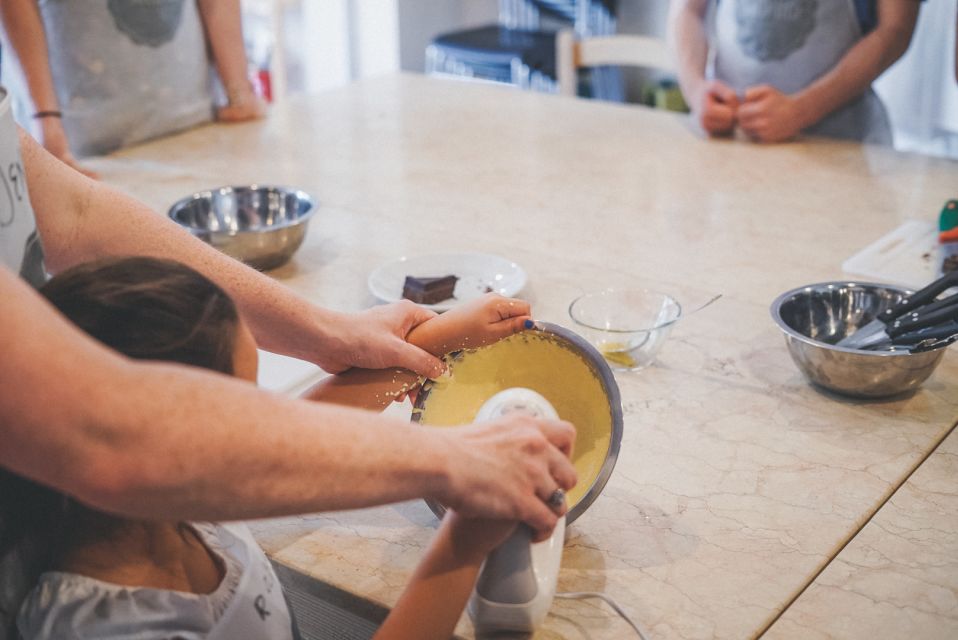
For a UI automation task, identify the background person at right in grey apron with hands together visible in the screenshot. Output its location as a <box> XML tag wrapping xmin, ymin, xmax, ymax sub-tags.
<box><xmin>671</xmin><ymin>0</ymin><xmax>919</xmax><ymax>145</ymax></box>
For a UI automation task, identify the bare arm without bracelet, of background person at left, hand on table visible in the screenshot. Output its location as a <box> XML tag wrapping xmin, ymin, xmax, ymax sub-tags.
<box><xmin>197</xmin><ymin>0</ymin><xmax>266</xmax><ymax>122</ymax></box>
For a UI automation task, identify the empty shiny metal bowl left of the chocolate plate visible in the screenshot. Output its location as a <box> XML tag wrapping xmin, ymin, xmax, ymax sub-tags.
<box><xmin>169</xmin><ymin>185</ymin><xmax>315</xmax><ymax>270</ymax></box>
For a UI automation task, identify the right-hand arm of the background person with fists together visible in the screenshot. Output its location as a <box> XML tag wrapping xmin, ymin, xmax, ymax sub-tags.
<box><xmin>739</xmin><ymin>0</ymin><xmax>920</xmax><ymax>142</ymax></box>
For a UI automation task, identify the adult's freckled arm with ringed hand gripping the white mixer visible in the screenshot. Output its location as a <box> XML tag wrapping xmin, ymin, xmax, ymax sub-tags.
<box><xmin>0</xmin><ymin>268</ymin><xmax>575</xmax><ymax>532</ymax></box>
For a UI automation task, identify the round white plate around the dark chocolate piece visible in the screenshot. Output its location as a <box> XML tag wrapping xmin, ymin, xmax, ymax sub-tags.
<box><xmin>368</xmin><ymin>253</ymin><xmax>526</xmax><ymax>311</ymax></box>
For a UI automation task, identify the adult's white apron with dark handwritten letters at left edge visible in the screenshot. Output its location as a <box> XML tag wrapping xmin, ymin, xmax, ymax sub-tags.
<box><xmin>0</xmin><ymin>87</ymin><xmax>46</xmax><ymax>287</ymax></box>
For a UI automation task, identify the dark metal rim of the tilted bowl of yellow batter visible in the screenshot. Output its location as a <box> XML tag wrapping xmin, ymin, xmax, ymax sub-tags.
<box><xmin>412</xmin><ymin>322</ymin><xmax>624</xmax><ymax>524</ymax></box>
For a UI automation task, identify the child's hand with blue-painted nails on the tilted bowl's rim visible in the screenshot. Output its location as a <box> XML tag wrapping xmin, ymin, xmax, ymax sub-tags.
<box><xmin>406</xmin><ymin>293</ymin><xmax>531</xmax><ymax>356</ymax></box>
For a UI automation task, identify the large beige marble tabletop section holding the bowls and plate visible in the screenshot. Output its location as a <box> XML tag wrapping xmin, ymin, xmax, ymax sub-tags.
<box><xmin>95</xmin><ymin>76</ymin><xmax>958</xmax><ymax>639</ymax></box>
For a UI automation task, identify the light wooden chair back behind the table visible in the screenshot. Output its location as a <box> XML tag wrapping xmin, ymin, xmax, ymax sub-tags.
<box><xmin>556</xmin><ymin>30</ymin><xmax>676</xmax><ymax>96</ymax></box>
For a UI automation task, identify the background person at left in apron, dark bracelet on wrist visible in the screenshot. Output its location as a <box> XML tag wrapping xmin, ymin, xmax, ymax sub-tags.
<box><xmin>0</xmin><ymin>0</ymin><xmax>266</xmax><ymax>177</ymax></box>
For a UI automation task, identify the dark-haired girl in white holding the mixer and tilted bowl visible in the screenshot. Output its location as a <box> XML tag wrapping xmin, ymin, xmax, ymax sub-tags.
<box><xmin>0</xmin><ymin>258</ymin><xmax>564</xmax><ymax>640</ymax></box>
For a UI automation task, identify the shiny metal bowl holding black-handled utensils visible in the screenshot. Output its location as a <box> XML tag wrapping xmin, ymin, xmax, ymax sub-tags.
<box><xmin>771</xmin><ymin>282</ymin><xmax>945</xmax><ymax>398</ymax></box>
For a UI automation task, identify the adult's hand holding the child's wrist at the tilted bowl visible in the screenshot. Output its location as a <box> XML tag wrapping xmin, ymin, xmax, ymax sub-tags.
<box><xmin>314</xmin><ymin>300</ymin><xmax>443</xmax><ymax>378</ymax></box>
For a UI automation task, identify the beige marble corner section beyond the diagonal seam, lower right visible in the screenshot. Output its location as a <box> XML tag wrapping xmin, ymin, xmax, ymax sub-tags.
<box><xmin>766</xmin><ymin>424</ymin><xmax>958</xmax><ymax>640</ymax></box>
